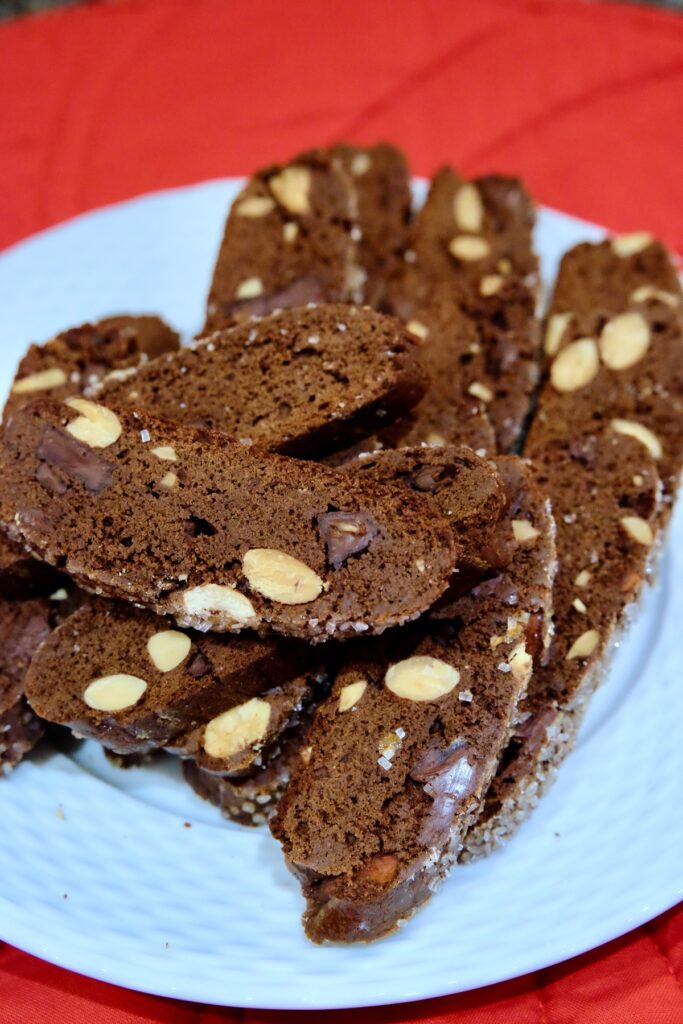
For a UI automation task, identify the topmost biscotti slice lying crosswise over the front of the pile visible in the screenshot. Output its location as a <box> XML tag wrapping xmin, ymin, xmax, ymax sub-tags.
<box><xmin>0</xmin><ymin>398</ymin><xmax>458</xmax><ymax>640</ymax></box>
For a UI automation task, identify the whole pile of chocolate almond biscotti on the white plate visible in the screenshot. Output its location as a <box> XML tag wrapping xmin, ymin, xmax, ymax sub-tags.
<box><xmin>0</xmin><ymin>143</ymin><xmax>683</xmax><ymax>942</ymax></box>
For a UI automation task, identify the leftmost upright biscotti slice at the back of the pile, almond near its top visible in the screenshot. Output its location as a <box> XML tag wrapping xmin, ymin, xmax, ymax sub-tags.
<box><xmin>205</xmin><ymin>151</ymin><xmax>362</xmax><ymax>332</ymax></box>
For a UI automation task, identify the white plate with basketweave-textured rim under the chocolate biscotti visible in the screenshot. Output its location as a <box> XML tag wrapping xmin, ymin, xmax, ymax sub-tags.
<box><xmin>0</xmin><ymin>181</ymin><xmax>683</xmax><ymax>1009</ymax></box>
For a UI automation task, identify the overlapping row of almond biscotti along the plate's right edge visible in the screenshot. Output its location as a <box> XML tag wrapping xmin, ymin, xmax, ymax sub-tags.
<box><xmin>465</xmin><ymin>232</ymin><xmax>683</xmax><ymax>857</ymax></box>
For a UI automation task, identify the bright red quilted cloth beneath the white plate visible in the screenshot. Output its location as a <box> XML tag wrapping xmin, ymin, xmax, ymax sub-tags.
<box><xmin>0</xmin><ymin>0</ymin><xmax>683</xmax><ymax>1024</ymax></box>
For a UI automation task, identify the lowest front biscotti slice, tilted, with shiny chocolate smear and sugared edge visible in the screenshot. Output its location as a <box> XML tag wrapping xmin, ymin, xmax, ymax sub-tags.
<box><xmin>271</xmin><ymin>458</ymin><xmax>555</xmax><ymax>942</ymax></box>
